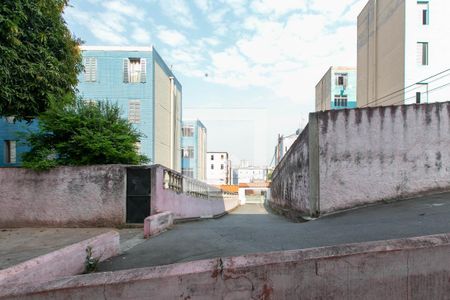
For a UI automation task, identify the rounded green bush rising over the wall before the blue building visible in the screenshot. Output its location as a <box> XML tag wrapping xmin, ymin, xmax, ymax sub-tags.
<box><xmin>22</xmin><ymin>99</ymin><xmax>148</xmax><ymax>170</ymax></box>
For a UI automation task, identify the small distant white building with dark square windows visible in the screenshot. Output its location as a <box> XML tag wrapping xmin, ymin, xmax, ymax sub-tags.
<box><xmin>206</xmin><ymin>152</ymin><xmax>231</xmax><ymax>185</ymax></box>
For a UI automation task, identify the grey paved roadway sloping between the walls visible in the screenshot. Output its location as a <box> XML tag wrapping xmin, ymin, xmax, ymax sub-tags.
<box><xmin>100</xmin><ymin>193</ymin><xmax>450</xmax><ymax>271</ymax></box>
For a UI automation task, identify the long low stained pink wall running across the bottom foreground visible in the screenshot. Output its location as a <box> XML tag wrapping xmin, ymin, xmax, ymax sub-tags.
<box><xmin>0</xmin><ymin>234</ymin><xmax>450</xmax><ymax>300</ymax></box>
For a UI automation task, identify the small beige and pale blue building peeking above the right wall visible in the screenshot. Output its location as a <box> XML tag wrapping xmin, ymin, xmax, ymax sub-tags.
<box><xmin>316</xmin><ymin>67</ymin><xmax>356</xmax><ymax>111</ymax></box>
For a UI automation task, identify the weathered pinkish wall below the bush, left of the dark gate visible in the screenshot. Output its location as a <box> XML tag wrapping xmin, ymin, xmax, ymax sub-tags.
<box><xmin>0</xmin><ymin>165</ymin><xmax>126</xmax><ymax>227</ymax></box>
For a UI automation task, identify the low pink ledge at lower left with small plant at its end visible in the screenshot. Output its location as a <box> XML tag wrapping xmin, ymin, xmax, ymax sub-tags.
<box><xmin>0</xmin><ymin>231</ymin><xmax>119</xmax><ymax>295</ymax></box>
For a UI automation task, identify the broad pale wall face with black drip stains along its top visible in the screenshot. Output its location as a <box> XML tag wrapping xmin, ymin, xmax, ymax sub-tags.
<box><xmin>319</xmin><ymin>102</ymin><xmax>450</xmax><ymax>213</ymax></box>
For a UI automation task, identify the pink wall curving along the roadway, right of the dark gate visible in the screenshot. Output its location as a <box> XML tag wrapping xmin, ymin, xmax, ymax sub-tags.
<box><xmin>151</xmin><ymin>166</ymin><xmax>239</xmax><ymax>219</ymax></box>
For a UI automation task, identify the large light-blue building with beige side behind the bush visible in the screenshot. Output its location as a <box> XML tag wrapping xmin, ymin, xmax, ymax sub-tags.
<box><xmin>0</xmin><ymin>46</ymin><xmax>182</xmax><ymax>171</ymax></box>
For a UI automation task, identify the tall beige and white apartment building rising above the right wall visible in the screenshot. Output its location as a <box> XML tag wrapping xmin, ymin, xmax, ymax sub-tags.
<box><xmin>357</xmin><ymin>0</ymin><xmax>450</xmax><ymax>107</ymax></box>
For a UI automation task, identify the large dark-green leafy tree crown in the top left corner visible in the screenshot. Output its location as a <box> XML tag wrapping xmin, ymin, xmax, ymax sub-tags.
<box><xmin>0</xmin><ymin>0</ymin><xmax>82</xmax><ymax>121</ymax></box>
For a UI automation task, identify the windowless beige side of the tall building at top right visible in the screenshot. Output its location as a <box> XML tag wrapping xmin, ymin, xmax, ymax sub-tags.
<box><xmin>357</xmin><ymin>0</ymin><xmax>405</xmax><ymax>107</ymax></box>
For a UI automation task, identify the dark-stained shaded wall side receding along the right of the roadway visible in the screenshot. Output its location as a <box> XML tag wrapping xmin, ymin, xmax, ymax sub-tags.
<box><xmin>269</xmin><ymin>126</ymin><xmax>310</xmax><ymax>215</ymax></box>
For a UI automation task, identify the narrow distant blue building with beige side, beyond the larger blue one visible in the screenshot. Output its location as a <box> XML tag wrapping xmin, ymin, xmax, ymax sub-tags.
<box><xmin>181</xmin><ymin>120</ymin><xmax>207</xmax><ymax>181</ymax></box>
